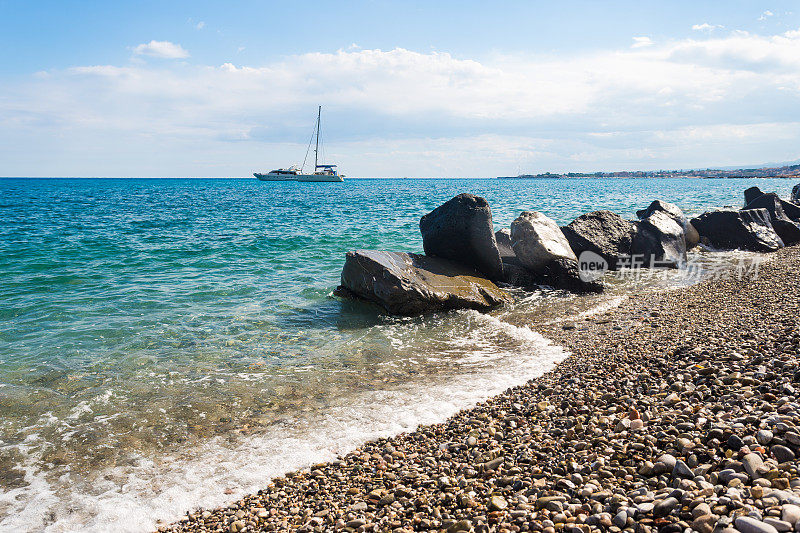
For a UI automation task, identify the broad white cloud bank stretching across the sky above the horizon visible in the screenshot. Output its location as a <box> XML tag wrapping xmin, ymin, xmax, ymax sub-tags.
<box><xmin>0</xmin><ymin>30</ymin><xmax>800</xmax><ymax>176</ymax></box>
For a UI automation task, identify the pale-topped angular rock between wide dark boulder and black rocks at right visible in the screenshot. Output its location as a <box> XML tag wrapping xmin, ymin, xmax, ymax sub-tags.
<box><xmin>631</xmin><ymin>210</ymin><xmax>686</xmax><ymax>268</ymax></box>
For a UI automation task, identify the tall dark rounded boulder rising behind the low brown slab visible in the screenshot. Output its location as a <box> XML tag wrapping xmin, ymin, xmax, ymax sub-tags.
<box><xmin>419</xmin><ymin>193</ymin><xmax>503</xmax><ymax>279</ymax></box>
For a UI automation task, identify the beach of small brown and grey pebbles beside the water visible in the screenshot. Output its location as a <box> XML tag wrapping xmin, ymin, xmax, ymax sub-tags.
<box><xmin>164</xmin><ymin>247</ymin><xmax>800</xmax><ymax>533</ymax></box>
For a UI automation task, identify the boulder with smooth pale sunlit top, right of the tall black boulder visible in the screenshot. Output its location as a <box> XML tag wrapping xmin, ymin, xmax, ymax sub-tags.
<box><xmin>511</xmin><ymin>211</ymin><xmax>603</xmax><ymax>293</ymax></box>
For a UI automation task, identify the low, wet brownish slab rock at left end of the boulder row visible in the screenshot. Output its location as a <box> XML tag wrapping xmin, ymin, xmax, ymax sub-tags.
<box><xmin>336</xmin><ymin>250</ymin><xmax>510</xmax><ymax>315</ymax></box>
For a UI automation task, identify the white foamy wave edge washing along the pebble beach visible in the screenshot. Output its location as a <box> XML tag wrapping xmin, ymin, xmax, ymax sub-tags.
<box><xmin>0</xmin><ymin>311</ymin><xmax>567</xmax><ymax>532</ymax></box>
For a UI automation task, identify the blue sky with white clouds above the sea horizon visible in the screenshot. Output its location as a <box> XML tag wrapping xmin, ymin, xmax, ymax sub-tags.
<box><xmin>0</xmin><ymin>0</ymin><xmax>800</xmax><ymax>177</ymax></box>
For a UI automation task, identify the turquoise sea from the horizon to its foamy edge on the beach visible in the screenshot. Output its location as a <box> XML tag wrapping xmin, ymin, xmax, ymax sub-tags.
<box><xmin>0</xmin><ymin>179</ymin><xmax>793</xmax><ymax>531</ymax></box>
